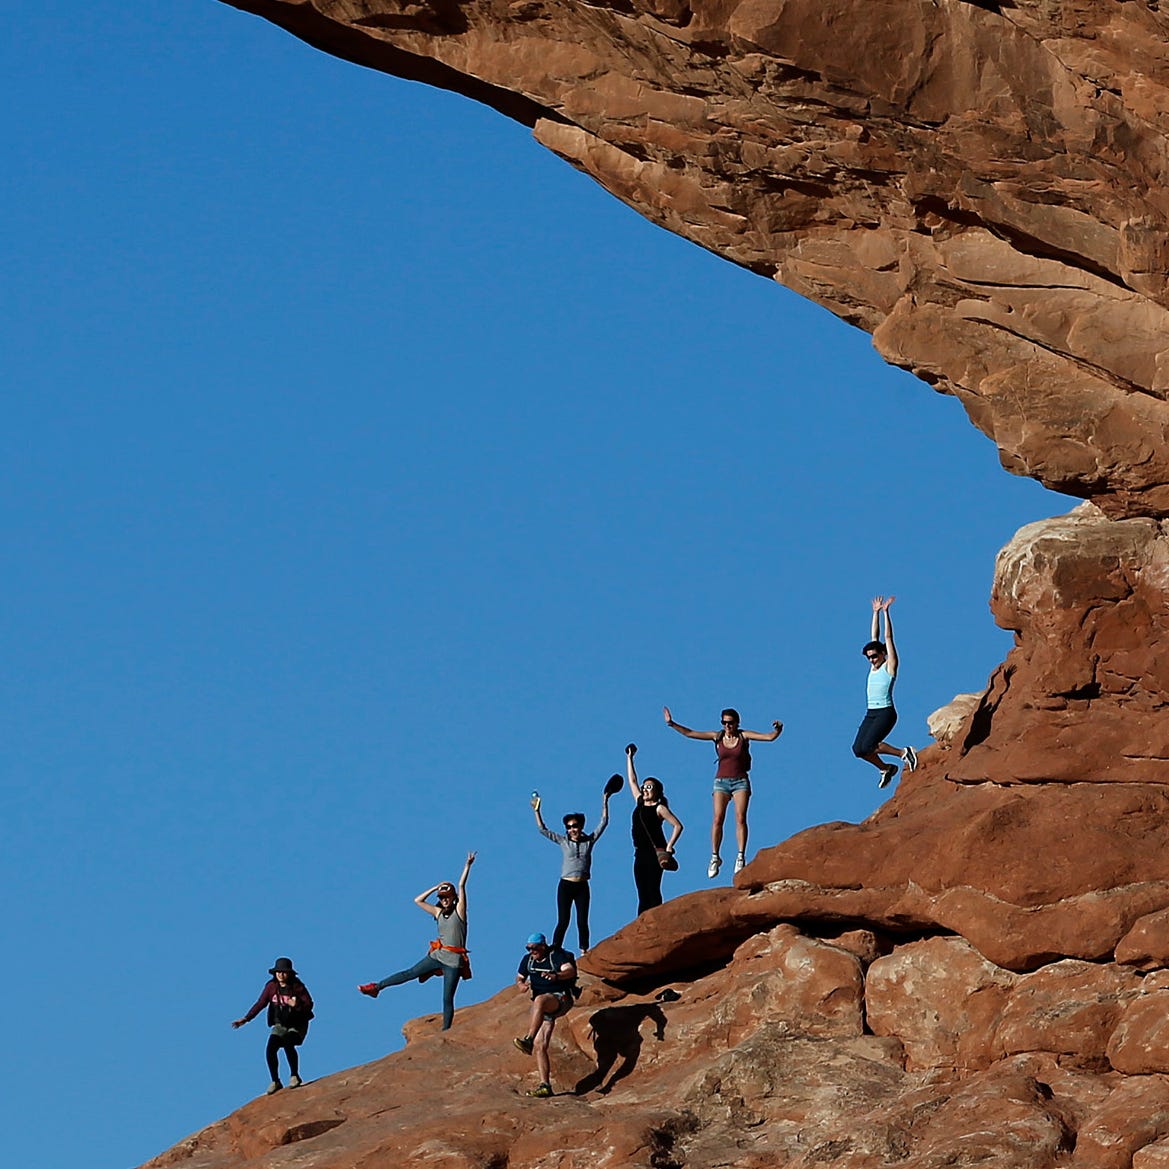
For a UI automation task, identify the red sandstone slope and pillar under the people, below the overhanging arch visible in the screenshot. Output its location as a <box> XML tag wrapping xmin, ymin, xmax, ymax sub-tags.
<box><xmin>147</xmin><ymin>504</ymin><xmax>1169</xmax><ymax>1169</ymax></box>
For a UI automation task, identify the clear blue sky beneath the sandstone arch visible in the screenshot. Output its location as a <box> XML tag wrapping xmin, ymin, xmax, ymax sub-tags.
<box><xmin>0</xmin><ymin>0</ymin><xmax>1071</xmax><ymax>1169</ymax></box>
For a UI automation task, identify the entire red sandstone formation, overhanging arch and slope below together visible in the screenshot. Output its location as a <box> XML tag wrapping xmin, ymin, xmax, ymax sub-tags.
<box><xmin>141</xmin><ymin>9</ymin><xmax>1169</xmax><ymax>1169</ymax></box>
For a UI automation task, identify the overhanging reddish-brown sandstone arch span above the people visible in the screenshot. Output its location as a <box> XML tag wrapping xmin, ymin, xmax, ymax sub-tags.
<box><xmin>220</xmin><ymin>0</ymin><xmax>1169</xmax><ymax>517</ymax></box>
